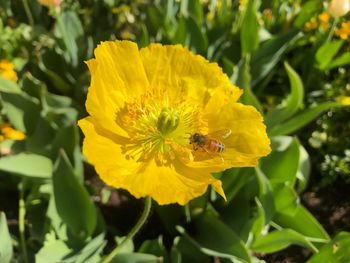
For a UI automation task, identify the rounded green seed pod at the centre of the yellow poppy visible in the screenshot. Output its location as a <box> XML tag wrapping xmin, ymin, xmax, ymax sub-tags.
<box><xmin>157</xmin><ymin>107</ymin><xmax>180</xmax><ymax>135</ymax></box>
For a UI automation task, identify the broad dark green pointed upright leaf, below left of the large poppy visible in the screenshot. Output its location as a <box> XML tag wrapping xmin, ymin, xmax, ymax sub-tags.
<box><xmin>53</xmin><ymin>151</ymin><xmax>97</xmax><ymax>239</ymax></box>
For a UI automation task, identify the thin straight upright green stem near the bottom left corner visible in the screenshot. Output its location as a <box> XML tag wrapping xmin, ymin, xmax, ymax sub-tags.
<box><xmin>18</xmin><ymin>180</ymin><xmax>29</xmax><ymax>263</ymax></box>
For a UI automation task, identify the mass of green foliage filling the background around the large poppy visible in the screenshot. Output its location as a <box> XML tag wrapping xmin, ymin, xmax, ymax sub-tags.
<box><xmin>0</xmin><ymin>0</ymin><xmax>350</xmax><ymax>263</ymax></box>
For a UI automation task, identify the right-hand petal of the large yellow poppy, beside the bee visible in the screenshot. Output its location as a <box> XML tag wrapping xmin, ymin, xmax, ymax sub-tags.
<box><xmin>204</xmin><ymin>103</ymin><xmax>271</xmax><ymax>167</ymax></box>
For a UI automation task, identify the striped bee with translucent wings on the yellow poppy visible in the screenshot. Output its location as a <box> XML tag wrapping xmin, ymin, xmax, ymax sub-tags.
<box><xmin>190</xmin><ymin>129</ymin><xmax>231</xmax><ymax>155</ymax></box>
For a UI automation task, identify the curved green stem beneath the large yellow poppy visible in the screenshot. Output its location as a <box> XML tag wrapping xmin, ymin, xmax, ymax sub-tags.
<box><xmin>101</xmin><ymin>196</ymin><xmax>152</xmax><ymax>263</ymax></box>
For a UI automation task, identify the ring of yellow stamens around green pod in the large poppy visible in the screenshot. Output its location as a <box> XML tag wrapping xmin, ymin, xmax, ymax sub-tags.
<box><xmin>116</xmin><ymin>95</ymin><xmax>202</xmax><ymax>165</ymax></box>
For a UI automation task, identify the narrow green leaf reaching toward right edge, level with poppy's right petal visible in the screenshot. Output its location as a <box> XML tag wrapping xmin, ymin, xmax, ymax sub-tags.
<box><xmin>269</xmin><ymin>102</ymin><xmax>344</xmax><ymax>136</ymax></box>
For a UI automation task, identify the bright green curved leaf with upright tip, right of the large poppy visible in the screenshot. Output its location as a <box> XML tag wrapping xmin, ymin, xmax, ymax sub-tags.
<box><xmin>266</xmin><ymin>62</ymin><xmax>304</xmax><ymax>129</ymax></box>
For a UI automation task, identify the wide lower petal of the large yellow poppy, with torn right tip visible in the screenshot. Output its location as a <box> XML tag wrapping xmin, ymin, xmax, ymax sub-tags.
<box><xmin>79</xmin><ymin>117</ymin><xmax>225</xmax><ymax>205</ymax></box>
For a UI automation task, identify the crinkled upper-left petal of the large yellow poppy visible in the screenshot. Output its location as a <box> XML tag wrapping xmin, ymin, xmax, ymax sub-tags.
<box><xmin>86</xmin><ymin>41</ymin><xmax>149</xmax><ymax>136</ymax></box>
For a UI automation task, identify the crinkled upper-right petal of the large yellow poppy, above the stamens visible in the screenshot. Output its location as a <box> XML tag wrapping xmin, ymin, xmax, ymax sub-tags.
<box><xmin>140</xmin><ymin>44</ymin><xmax>241</xmax><ymax>106</ymax></box>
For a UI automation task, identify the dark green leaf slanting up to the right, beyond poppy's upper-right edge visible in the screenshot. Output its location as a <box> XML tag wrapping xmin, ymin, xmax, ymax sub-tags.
<box><xmin>250</xmin><ymin>29</ymin><xmax>300</xmax><ymax>87</ymax></box>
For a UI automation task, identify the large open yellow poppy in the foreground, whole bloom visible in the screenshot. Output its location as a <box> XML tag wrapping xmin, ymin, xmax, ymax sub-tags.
<box><xmin>78</xmin><ymin>41</ymin><xmax>270</xmax><ymax>205</ymax></box>
